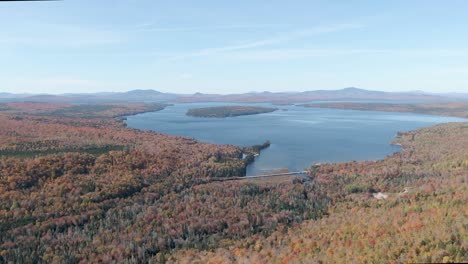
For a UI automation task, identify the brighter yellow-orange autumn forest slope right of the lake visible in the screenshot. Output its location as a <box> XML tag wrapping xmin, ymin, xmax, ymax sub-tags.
<box><xmin>172</xmin><ymin>123</ymin><xmax>468</xmax><ymax>263</ymax></box>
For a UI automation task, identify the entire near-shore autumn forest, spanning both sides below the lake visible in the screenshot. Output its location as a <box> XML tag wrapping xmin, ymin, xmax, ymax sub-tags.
<box><xmin>0</xmin><ymin>103</ymin><xmax>468</xmax><ymax>263</ymax></box>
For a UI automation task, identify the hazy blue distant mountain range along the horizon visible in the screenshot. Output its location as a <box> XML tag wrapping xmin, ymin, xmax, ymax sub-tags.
<box><xmin>0</xmin><ymin>87</ymin><xmax>468</xmax><ymax>104</ymax></box>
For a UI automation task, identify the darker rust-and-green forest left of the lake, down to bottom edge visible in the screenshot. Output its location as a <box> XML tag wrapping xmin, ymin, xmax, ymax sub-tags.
<box><xmin>0</xmin><ymin>102</ymin><xmax>329</xmax><ymax>263</ymax></box>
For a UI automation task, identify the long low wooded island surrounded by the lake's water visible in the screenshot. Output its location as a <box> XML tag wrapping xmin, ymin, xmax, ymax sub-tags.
<box><xmin>187</xmin><ymin>106</ymin><xmax>278</xmax><ymax>118</ymax></box>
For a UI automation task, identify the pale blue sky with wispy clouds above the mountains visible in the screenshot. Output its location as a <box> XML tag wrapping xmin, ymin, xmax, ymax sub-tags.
<box><xmin>0</xmin><ymin>0</ymin><xmax>468</xmax><ymax>93</ymax></box>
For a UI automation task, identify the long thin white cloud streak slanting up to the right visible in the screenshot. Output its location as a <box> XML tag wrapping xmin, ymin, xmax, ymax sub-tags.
<box><xmin>169</xmin><ymin>24</ymin><xmax>363</xmax><ymax>60</ymax></box>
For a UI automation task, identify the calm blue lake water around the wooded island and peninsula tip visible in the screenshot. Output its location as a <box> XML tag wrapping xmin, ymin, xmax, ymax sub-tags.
<box><xmin>127</xmin><ymin>103</ymin><xmax>466</xmax><ymax>175</ymax></box>
